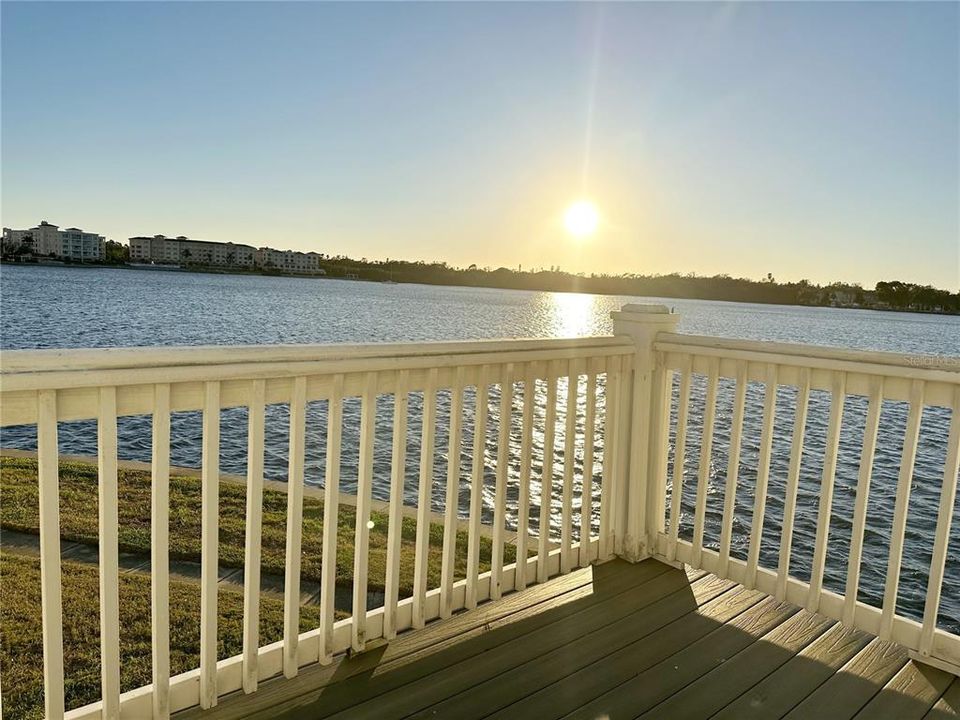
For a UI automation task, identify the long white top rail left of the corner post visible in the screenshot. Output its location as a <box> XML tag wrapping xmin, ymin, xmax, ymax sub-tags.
<box><xmin>0</xmin><ymin>335</ymin><xmax>631</xmax><ymax>375</ymax></box>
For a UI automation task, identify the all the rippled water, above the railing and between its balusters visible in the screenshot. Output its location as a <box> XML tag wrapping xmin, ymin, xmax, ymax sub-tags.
<box><xmin>0</xmin><ymin>266</ymin><xmax>960</xmax><ymax>631</ymax></box>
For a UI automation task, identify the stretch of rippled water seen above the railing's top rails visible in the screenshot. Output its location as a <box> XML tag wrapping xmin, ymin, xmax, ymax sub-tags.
<box><xmin>0</xmin><ymin>265</ymin><xmax>960</xmax><ymax>355</ymax></box>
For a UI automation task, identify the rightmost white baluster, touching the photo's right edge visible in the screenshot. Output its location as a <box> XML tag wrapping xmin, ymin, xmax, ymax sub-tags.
<box><xmin>920</xmin><ymin>387</ymin><xmax>960</xmax><ymax>657</ymax></box>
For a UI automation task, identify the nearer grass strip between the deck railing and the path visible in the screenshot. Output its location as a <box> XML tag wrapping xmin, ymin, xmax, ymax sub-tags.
<box><xmin>0</xmin><ymin>555</ymin><xmax>330</xmax><ymax>720</ymax></box>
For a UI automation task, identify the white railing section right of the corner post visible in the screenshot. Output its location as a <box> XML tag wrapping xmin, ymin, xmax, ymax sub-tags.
<box><xmin>648</xmin><ymin>333</ymin><xmax>960</xmax><ymax>673</ymax></box>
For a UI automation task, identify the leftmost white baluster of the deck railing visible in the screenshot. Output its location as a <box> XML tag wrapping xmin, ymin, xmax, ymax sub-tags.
<box><xmin>37</xmin><ymin>390</ymin><xmax>64</xmax><ymax>720</ymax></box>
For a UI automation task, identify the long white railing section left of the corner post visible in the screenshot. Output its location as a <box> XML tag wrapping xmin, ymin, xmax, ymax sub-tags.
<box><xmin>0</xmin><ymin>337</ymin><xmax>634</xmax><ymax>718</ymax></box>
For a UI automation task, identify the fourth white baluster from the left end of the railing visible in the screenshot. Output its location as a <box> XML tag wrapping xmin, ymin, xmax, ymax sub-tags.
<box><xmin>200</xmin><ymin>382</ymin><xmax>220</xmax><ymax>710</ymax></box>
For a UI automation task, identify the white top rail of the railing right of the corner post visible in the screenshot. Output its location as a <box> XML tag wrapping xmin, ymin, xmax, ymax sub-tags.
<box><xmin>654</xmin><ymin>333</ymin><xmax>960</xmax><ymax>383</ymax></box>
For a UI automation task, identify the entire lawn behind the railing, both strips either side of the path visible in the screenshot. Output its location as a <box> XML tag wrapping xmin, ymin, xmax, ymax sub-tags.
<box><xmin>0</xmin><ymin>457</ymin><xmax>516</xmax><ymax>720</ymax></box>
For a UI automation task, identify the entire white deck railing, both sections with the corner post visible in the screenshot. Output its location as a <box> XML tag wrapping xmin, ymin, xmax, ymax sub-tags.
<box><xmin>0</xmin><ymin>306</ymin><xmax>960</xmax><ymax>718</ymax></box>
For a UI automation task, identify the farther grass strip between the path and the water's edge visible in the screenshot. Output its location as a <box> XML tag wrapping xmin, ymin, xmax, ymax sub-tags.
<box><xmin>0</xmin><ymin>457</ymin><xmax>516</xmax><ymax>597</ymax></box>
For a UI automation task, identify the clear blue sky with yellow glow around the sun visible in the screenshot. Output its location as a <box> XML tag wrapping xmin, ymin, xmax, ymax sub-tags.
<box><xmin>0</xmin><ymin>2</ymin><xmax>960</xmax><ymax>291</ymax></box>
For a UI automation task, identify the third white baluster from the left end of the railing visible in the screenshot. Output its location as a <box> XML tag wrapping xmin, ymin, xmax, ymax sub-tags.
<box><xmin>150</xmin><ymin>384</ymin><xmax>170</xmax><ymax>720</ymax></box>
